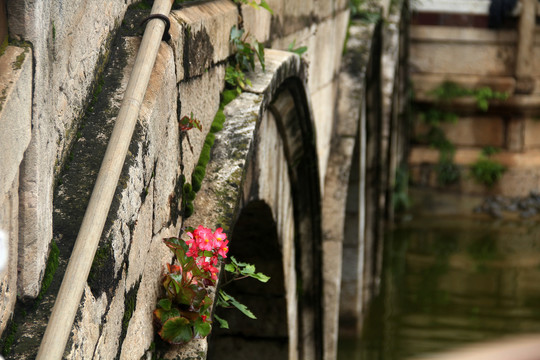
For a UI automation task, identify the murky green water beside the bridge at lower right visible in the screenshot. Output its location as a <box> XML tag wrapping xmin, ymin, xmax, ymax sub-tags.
<box><xmin>338</xmin><ymin>217</ymin><xmax>540</xmax><ymax>360</ymax></box>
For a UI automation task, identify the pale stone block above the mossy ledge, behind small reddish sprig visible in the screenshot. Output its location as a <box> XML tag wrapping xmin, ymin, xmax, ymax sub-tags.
<box><xmin>178</xmin><ymin>65</ymin><xmax>225</xmax><ymax>183</ymax></box>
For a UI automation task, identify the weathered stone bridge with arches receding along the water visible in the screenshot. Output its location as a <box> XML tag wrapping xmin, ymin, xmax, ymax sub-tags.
<box><xmin>0</xmin><ymin>0</ymin><xmax>407</xmax><ymax>360</ymax></box>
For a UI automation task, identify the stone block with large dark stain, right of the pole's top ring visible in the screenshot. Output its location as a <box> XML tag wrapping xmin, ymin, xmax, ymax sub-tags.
<box><xmin>170</xmin><ymin>0</ymin><xmax>238</xmax><ymax>82</ymax></box>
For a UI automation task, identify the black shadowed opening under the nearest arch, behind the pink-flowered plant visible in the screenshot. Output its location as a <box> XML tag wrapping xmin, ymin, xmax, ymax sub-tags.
<box><xmin>208</xmin><ymin>200</ymin><xmax>288</xmax><ymax>360</ymax></box>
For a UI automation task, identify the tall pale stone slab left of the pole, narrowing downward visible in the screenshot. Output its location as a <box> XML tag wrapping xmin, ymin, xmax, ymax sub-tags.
<box><xmin>8</xmin><ymin>0</ymin><xmax>126</xmax><ymax>297</ymax></box>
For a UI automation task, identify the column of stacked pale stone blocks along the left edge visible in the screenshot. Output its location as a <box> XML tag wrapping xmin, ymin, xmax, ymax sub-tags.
<box><xmin>0</xmin><ymin>46</ymin><xmax>32</xmax><ymax>334</ymax></box>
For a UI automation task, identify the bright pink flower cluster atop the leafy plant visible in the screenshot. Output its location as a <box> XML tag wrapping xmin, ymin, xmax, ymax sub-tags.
<box><xmin>186</xmin><ymin>225</ymin><xmax>229</xmax><ymax>281</ymax></box>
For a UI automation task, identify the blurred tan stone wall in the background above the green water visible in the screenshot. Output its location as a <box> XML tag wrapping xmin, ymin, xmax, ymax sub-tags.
<box><xmin>409</xmin><ymin>21</ymin><xmax>540</xmax><ymax>196</ymax></box>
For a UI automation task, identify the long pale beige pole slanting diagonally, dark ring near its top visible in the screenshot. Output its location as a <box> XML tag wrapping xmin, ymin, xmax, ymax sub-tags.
<box><xmin>36</xmin><ymin>0</ymin><xmax>174</xmax><ymax>360</ymax></box>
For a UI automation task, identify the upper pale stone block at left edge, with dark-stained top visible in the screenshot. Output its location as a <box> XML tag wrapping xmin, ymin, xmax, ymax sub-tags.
<box><xmin>0</xmin><ymin>46</ymin><xmax>32</xmax><ymax>200</ymax></box>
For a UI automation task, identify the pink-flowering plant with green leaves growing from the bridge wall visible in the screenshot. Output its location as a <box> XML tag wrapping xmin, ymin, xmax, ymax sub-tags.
<box><xmin>154</xmin><ymin>225</ymin><xmax>270</xmax><ymax>344</ymax></box>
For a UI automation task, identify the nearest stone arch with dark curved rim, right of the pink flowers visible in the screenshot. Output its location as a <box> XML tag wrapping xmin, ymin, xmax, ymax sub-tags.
<box><xmin>202</xmin><ymin>51</ymin><xmax>323</xmax><ymax>359</ymax></box>
